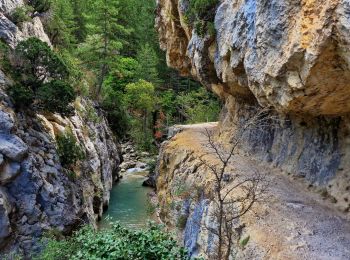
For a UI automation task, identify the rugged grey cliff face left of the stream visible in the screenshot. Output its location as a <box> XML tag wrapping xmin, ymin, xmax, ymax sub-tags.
<box><xmin>0</xmin><ymin>0</ymin><xmax>120</xmax><ymax>254</ymax></box>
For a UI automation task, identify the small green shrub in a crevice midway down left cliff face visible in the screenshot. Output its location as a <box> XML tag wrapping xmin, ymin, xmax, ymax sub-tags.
<box><xmin>56</xmin><ymin>129</ymin><xmax>85</xmax><ymax>168</ymax></box>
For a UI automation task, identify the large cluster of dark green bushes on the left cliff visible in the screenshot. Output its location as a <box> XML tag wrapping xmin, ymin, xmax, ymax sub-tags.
<box><xmin>7</xmin><ymin>38</ymin><xmax>76</xmax><ymax>115</ymax></box>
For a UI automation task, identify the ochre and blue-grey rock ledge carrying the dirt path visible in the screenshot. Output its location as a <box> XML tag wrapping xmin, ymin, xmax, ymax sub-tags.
<box><xmin>156</xmin><ymin>125</ymin><xmax>350</xmax><ymax>260</ymax></box>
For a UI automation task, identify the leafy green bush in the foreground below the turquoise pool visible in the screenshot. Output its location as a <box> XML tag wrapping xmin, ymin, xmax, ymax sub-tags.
<box><xmin>35</xmin><ymin>221</ymin><xmax>189</xmax><ymax>260</ymax></box>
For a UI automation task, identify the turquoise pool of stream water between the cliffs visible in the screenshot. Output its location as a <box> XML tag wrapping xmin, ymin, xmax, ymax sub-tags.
<box><xmin>99</xmin><ymin>169</ymin><xmax>152</xmax><ymax>228</ymax></box>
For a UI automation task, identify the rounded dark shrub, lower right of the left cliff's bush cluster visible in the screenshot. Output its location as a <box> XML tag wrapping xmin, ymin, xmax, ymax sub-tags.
<box><xmin>37</xmin><ymin>80</ymin><xmax>76</xmax><ymax>116</ymax></box>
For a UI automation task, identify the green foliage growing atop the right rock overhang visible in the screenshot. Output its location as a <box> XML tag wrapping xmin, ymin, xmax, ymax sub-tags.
<box><xmin>185</xmin><ymin>0</ymin><xmax>219</xmax><ymax>37</ymax></box>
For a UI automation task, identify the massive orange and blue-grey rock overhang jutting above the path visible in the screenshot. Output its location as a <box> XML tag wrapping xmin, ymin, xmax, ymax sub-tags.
<box><xmin>157</xmin><ymin>0</ymin><xmax>350</xmax><ymax>115</ymax></box>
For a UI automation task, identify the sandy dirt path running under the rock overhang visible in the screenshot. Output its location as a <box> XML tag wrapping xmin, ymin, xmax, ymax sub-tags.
<box><xmin>170</xmin><ymin>123</ymin><xmax>350</xmax><ymax>260</ymax></box>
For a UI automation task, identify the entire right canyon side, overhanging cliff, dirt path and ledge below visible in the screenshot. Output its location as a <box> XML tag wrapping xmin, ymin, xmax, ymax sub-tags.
<box><xmin>156</xmin><ymin>0</ymin><xmax>350</xmax><ymax>259</ymax></box>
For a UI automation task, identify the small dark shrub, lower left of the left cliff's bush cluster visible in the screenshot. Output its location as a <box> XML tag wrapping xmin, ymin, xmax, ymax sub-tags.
<box><xmin>7</xmin><ymin>84</ymin><xmax>34</xmax><ymax>108</ymax></box>
